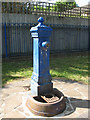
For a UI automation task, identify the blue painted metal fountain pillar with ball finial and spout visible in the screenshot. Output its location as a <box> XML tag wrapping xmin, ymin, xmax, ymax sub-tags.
<box><xmin>30</xmin><ymin>17</ymin><xmax>53</xmax><ymax>95</ymax></box>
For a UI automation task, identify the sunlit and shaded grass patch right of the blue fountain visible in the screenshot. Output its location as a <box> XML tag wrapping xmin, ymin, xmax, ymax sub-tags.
<box><xmin>50</xmin><ymin>56</ymin><xmax>88</xmax><ymax>84</ymax></box>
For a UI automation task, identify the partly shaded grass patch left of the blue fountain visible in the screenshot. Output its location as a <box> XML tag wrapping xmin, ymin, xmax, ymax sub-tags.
<box><xmin>2</xmin><ymin>59</ymin><xmax>32</xmax><ymax>85</ymax></box>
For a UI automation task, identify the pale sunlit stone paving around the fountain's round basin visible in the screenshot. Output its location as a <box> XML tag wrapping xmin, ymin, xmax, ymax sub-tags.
<box><xmin>0</xmin><ymin>79</ymin><xmax>90</xmax><ymax>120</ymax></box>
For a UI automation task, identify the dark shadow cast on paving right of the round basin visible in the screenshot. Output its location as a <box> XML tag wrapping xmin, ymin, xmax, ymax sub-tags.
<box><xmin>57</xmin><ymin>96</ymin><xmax>90</xmax><ymax>117</ymax></box>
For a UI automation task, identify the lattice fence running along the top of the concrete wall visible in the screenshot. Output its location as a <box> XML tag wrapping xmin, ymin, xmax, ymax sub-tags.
<box><xmin>2</xmin><ymin>2</ymin><xmax>90</xmax><ymax>18</ymax></box>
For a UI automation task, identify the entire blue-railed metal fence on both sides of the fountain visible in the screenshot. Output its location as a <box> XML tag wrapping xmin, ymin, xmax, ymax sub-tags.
<box><xmin>2</xmin><ymin>23</ymin><xmax>88</xmax><ymax>57</ymax></box>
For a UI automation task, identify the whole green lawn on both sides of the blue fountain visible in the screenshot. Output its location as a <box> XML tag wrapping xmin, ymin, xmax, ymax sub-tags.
<box><xmin>2</xmin><ymin>55</ymin><xmax>88</xmax><ymax>85</ymax></box>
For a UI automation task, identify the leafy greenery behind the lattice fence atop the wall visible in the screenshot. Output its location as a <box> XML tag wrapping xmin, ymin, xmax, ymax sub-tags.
<box><xmin>2</xmin><ymin>2</ymin><xmax>76</xmax><ymax>13</ymax></box>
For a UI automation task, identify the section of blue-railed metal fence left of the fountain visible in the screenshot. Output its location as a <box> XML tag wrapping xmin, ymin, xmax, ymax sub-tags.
<box><xmin>2</xmin><ymin>23</ymin><xmax>35</xmax><ymax>57</ymax></box>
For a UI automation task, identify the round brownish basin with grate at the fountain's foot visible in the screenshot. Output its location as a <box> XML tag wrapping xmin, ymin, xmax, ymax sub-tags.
<box><xmin>26</xmin><ymin>89</ymin><xmax>66</xmax><ymax>117</ymax></box>
